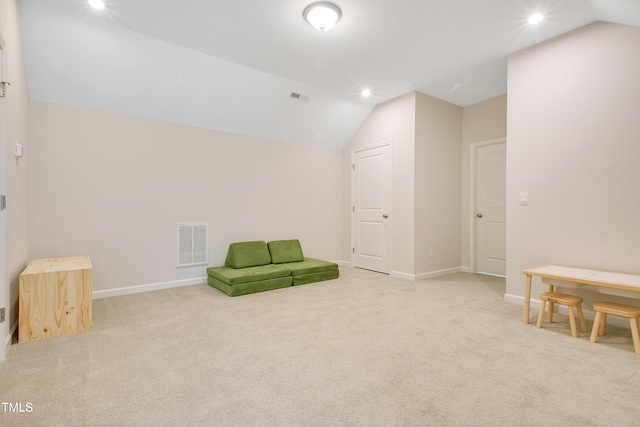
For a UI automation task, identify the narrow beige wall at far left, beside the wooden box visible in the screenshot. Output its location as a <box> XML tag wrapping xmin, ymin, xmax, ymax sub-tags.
<box><xmin>0</xmin><ymin>0</ymin><xmax>31</xmax><ymax>333</ymax></box>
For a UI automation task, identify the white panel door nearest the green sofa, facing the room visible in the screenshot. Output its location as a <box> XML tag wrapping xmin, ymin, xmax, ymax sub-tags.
<box><xmin>352</xmin><ymin>144</ymin><xmax>391</xmax><ymax>274</ymax></box>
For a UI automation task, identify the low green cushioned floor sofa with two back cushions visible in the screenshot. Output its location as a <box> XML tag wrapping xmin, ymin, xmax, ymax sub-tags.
<box><xmin>207</xmin><ymin>239</ymin><xmax>340</xmax><ymax>297</ymax></box>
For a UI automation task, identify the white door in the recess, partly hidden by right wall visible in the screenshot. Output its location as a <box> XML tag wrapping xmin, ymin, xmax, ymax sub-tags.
<box><xmin>475</xmin><ymin>142</ymin><xmax>507</xmax><ymax>276</ymax></box>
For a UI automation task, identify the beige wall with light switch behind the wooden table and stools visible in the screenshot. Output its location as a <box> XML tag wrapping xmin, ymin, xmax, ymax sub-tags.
<box><xmin>506</xmin><ymin>23</ymin><xmax>640</xmax><ymax>308</ymax></box>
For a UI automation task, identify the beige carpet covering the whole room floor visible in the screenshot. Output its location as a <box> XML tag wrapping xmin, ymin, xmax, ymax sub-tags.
<box><xmin>0</xmin><ymin>267</ymin><xmax>640</xmax><ymax>426</ymax></box>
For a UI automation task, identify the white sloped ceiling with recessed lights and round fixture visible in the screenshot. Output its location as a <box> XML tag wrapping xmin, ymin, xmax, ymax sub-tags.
<box><xmin>19</xmin><ymin>0</ymin><xmax>640</xmax><ymax>149</ymax></box>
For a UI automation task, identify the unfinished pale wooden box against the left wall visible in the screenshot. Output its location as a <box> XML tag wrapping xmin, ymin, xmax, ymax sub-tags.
<box><xmin>18</xmin><ymin>256</ymin><xmax>93</xmax><ymax>343</ymax></box>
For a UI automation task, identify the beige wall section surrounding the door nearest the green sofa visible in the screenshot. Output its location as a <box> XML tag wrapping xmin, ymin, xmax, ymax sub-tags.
<box><xmin>342</xmin><ymin>92</ymin><xmax>416</xmax><ymax>274</ymax></box>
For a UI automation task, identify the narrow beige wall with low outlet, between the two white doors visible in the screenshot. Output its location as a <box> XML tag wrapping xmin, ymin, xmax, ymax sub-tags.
<box><xmin>414</xmin><ymin>92</ymin><xmax>462</xmax><ymax>278</ymax></box>
